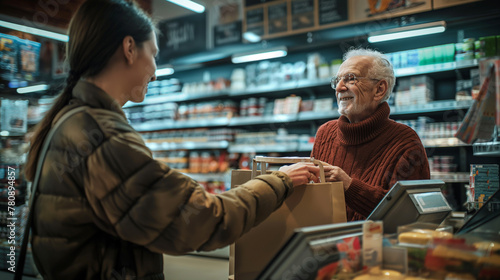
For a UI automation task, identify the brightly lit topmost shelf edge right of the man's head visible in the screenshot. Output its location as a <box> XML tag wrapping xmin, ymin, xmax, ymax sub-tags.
<box><xmin>394</xmin><ymin>59</ymin><xmax>478</xmax><ymax>77</ymax></box>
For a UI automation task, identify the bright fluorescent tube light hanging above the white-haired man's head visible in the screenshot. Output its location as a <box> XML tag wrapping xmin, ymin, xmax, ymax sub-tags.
<box><xmin>368</xmin><ymin>21</ymin><xmax>446</xmax><ymax>43</ymax></box>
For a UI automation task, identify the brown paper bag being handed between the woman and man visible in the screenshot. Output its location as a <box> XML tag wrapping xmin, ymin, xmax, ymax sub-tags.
<box><xmin>229</xmin><ymin>157</ymin><xmax>346</xmax><ymax>280</ymax></box>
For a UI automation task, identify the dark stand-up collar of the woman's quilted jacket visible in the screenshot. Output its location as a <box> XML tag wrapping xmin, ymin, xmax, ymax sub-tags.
<box><xmin>73</xmin><ymin>80</ymin><xmax>126</xmax><ymax>118</ymax></box>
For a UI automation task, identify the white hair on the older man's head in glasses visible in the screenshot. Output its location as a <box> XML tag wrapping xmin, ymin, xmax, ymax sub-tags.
<box><xmin>344</xmin><ymin>48</ymin><xmax>396</xmax><ymax>102</ymax></box>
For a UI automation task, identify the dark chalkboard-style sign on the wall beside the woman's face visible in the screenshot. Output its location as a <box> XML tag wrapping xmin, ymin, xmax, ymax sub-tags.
<box><xmin>158</xmin><ymin>13</ymin><xmax>207</xmax><ymax>63</ymax></box>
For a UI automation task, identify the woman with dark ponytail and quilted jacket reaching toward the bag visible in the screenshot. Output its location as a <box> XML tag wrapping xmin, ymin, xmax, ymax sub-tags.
<box><xmin>26</xmin><ymin>0</ymin><xmax>319</xmax><ymax>279</ymax></box>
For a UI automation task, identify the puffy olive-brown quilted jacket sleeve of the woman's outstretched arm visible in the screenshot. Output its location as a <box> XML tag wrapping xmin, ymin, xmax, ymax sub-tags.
<box><xmin>84</xmin><ymin>110</ymin><xmax>292</xmax><ymax>254</ymax></box>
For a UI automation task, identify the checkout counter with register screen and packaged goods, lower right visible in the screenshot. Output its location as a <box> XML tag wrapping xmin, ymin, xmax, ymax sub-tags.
<box><xmin>230</xmin><ymin>180</ymin><xmax>500</xmax><ymax>280</ymax></box>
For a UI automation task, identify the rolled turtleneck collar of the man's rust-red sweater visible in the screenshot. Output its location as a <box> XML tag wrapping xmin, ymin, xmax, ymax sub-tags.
<box><xmin>338</xmin><ymin>102</ymin><xmax>391</xmax><ymax>145</ymax></box>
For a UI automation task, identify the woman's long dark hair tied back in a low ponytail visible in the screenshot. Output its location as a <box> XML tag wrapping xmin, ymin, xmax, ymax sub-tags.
<box><xmin>25</xmin><ymin>0</ymin><xmax>154</xmax><ymax>181</ymax></box>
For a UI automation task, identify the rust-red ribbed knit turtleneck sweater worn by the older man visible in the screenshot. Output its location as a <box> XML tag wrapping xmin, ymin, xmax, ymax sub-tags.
<box><xmin>311</xmin><ymin>102</ymin><xmax>430</xmax><ymax>221</ymax></box>
